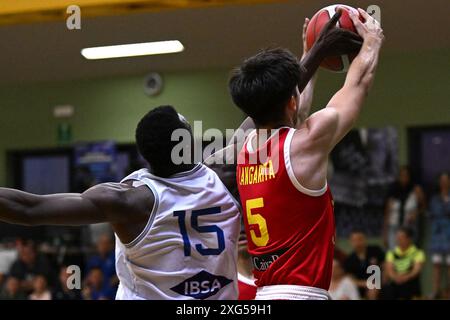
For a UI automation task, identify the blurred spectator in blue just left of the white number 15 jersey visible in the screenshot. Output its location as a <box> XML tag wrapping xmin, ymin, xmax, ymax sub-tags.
<box><xmin>86</xmin><ymin>233</ymin><xmax>119</xmax><ymax>288</ymax></box>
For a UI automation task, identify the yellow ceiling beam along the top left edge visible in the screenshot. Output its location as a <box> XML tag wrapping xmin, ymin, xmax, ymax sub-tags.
<box><xmin>0</xmin><ymin>0</ymin><xmax>283</xmax><ymax>25</ymax></box>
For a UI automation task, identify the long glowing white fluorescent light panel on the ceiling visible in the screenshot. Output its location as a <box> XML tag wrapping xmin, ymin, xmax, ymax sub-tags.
<box><xmin>81</xmin><ymin>40</ymin><xmax>184</xmax><ymax>60</ymax></box>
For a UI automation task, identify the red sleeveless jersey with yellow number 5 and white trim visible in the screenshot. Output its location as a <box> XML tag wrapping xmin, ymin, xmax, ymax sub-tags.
<box><xmin>236</xmin><ymin>128</ymin><xmax>335</xmax><ymax>290</ymax></box>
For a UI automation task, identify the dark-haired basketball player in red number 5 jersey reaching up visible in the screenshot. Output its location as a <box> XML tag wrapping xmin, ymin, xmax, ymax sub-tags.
<box><xmin>229</xmin><ymin>9</ymin><xmax>384</xmax><ymax>299</ymax></box>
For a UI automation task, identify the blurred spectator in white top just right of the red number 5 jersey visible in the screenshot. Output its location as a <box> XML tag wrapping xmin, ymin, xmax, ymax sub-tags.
<box><xmin>329</xmin><ymin>260</ymin><xmax>360</xmax><ymax>300</ymax></box>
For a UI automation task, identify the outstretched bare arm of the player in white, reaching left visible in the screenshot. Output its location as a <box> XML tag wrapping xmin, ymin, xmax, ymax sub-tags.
<box><xmin>0</xmin><ymin>183</ymin><xmax>153</xmax><ymax>226</ymax></box>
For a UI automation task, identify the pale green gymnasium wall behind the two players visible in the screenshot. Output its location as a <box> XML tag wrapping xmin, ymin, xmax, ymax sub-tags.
<box><xmin>0</xmin><ymin>48</ymin><xmax>450</xmax><ymax>185</ymax></box>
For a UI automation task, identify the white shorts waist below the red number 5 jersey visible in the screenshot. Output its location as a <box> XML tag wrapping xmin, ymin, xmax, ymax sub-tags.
<box><xmin>255</xmin><ymin>285</ymin><xmax>331</xmax><ymax>300</ymax></box>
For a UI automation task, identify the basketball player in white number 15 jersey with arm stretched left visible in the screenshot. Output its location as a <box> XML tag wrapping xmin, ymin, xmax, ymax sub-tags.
<box><xmin>0</xmin><ymin>106</ymin><xmax>240</xmax><ymax>300</ymax></box>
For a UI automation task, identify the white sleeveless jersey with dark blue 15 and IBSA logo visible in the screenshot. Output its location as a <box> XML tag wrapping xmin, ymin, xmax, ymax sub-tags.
<box><xmin>116</xmin><ymin>164</ymin><xmax>240</xmax><ymax>300</ymax></box>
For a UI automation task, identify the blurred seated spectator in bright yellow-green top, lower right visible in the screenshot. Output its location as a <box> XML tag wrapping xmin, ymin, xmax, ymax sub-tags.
<box><xmin>382</xmin><ymin>227</ymin><xmax>425</xmax><ymax>300</ymax></box>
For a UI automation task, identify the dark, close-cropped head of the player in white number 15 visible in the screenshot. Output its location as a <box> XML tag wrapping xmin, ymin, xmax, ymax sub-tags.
<box><xmin>136</xmin><ymin>106</ymin><xmax>192</xmax><ymax>177</ymax></box>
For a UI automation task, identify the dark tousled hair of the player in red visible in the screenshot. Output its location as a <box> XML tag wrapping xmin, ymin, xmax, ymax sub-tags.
<box><xmin>228</xmin><ymin>48</ymin><xmax>301</xmax><ymax>125</ymax></box>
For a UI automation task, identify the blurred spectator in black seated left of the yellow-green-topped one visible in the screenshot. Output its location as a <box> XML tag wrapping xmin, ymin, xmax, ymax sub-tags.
<box><xmin>344</xmin><ymin>230</ymin><xmax>385</xmax><ymax>300</ymax></box>
